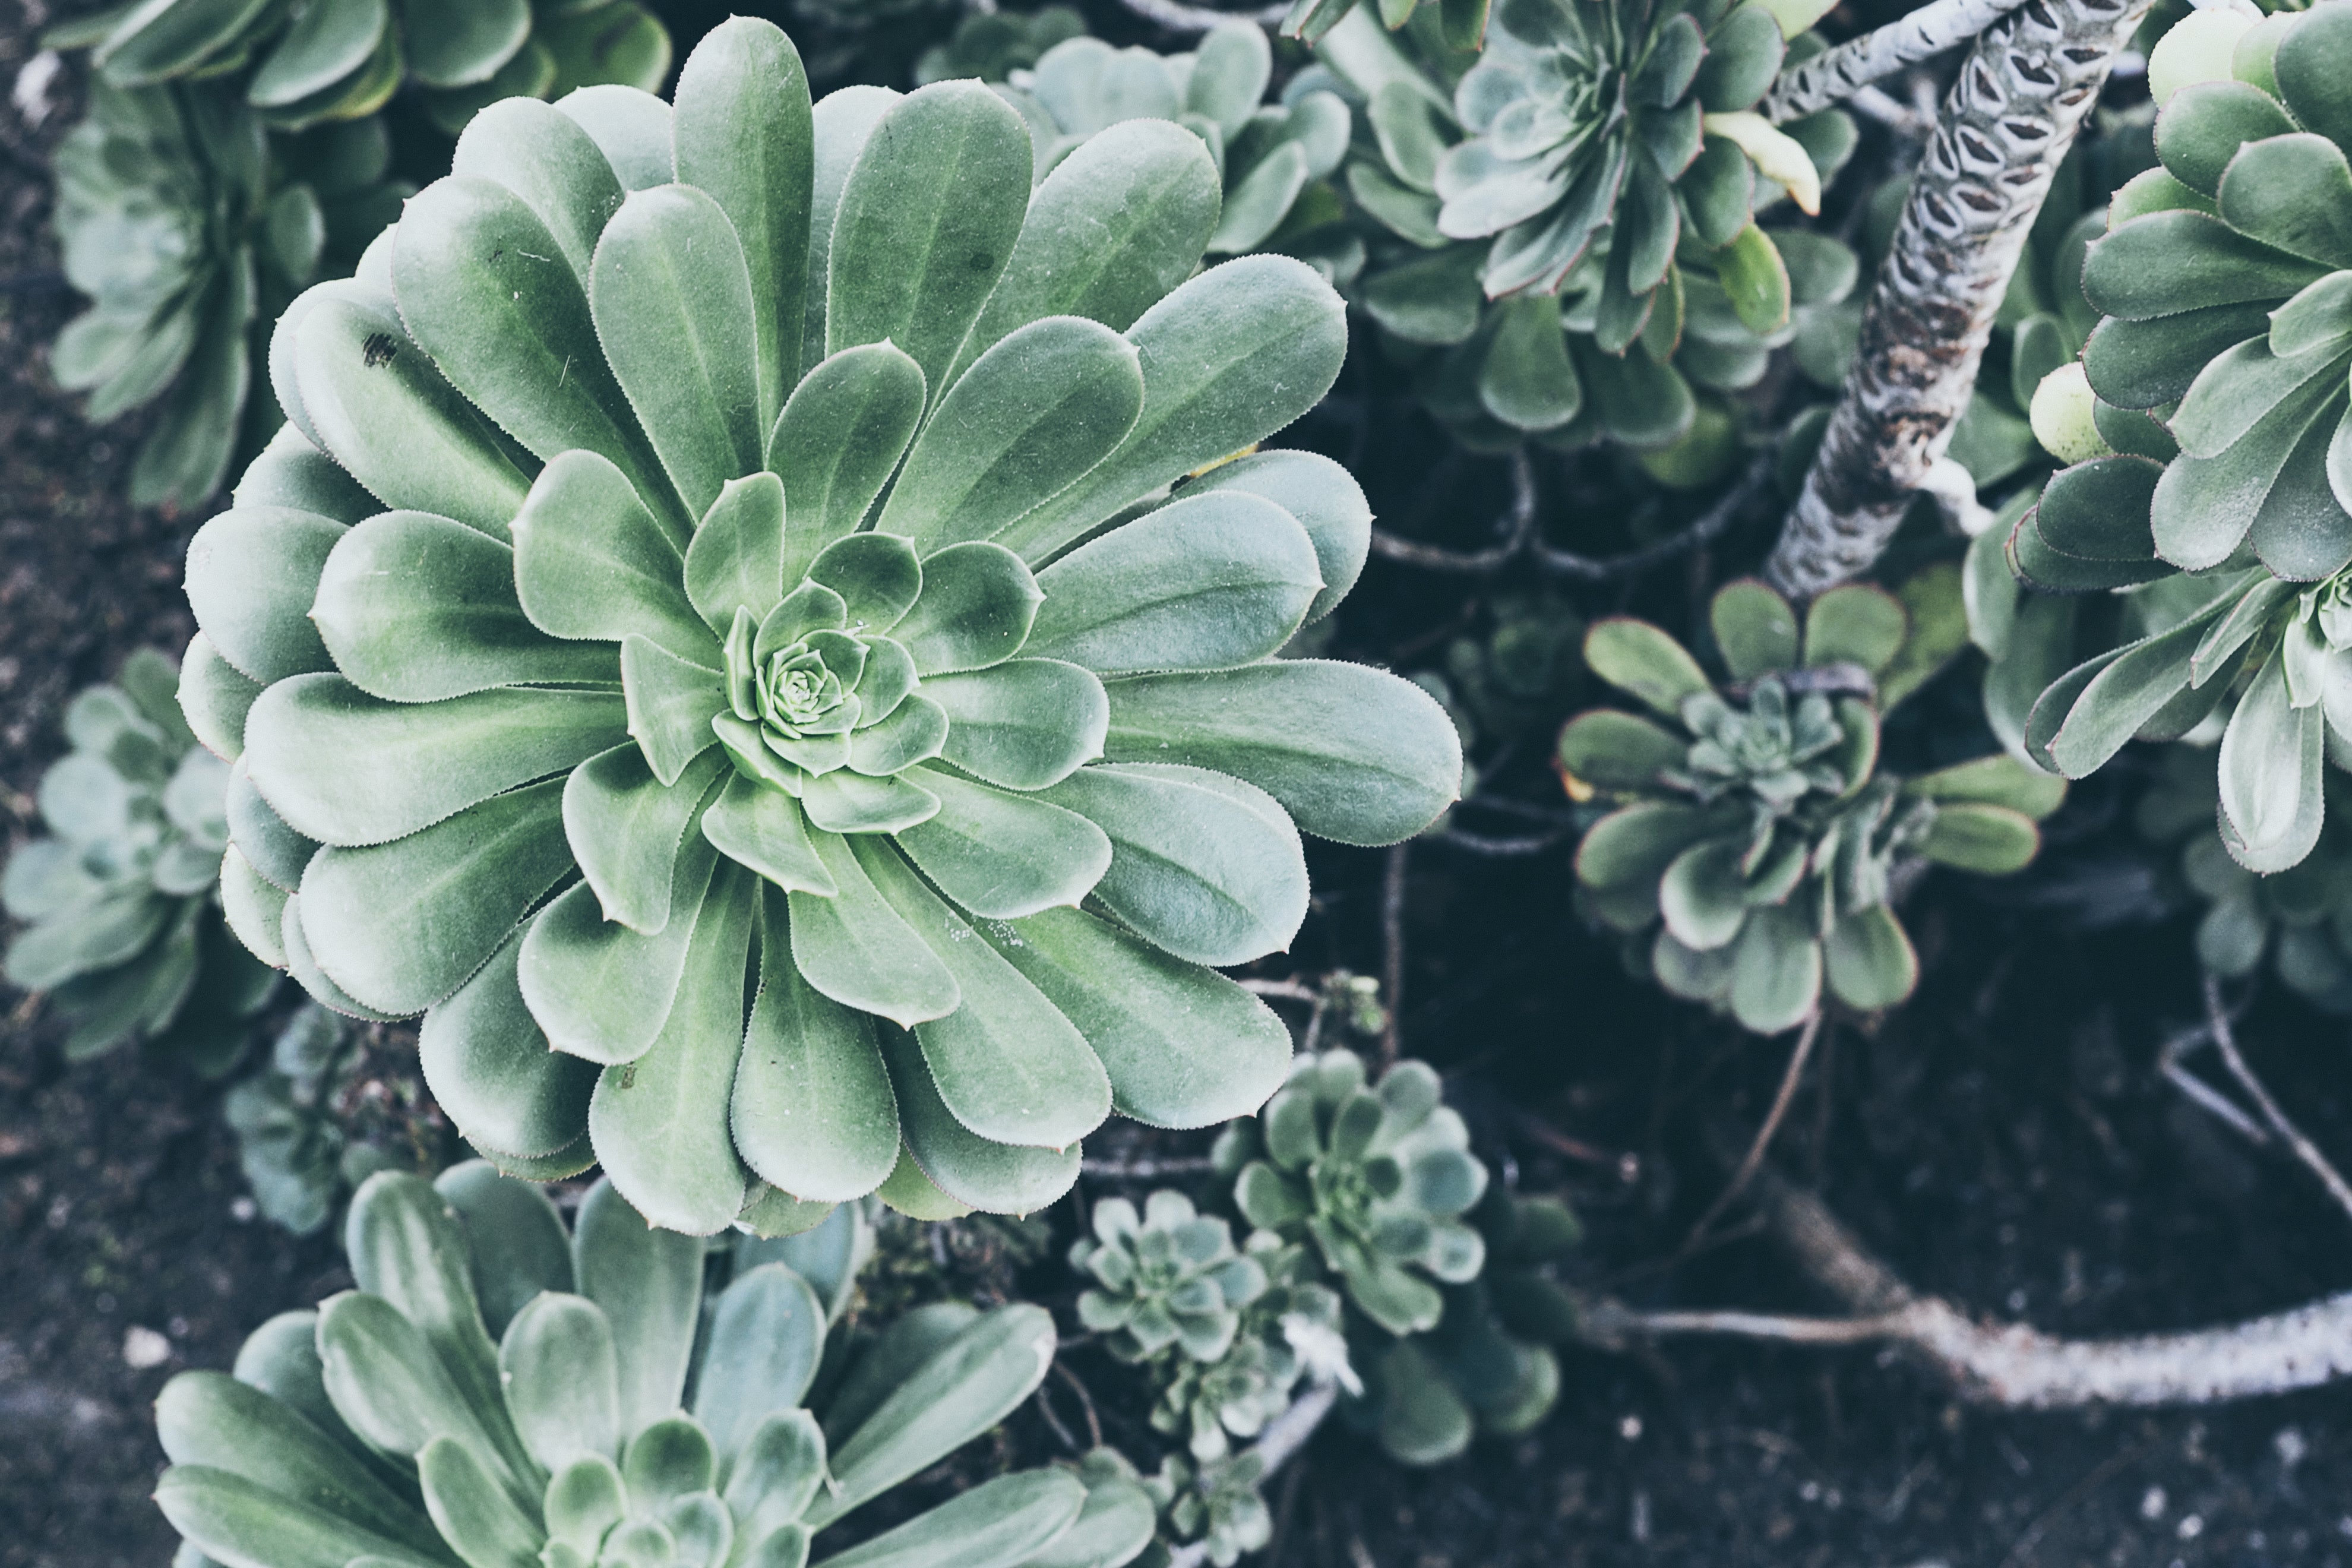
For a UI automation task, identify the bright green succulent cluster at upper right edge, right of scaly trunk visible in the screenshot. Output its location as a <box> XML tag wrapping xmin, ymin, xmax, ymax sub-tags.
<box><xmin>2009</xmin><ymin>7</ymin><xmax>2352</xmax><ymax>874</ymax></box>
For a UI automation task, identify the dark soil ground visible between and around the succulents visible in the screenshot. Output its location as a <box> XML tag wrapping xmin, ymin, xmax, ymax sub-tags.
<box><xmin>0</xmin><ymin>0</ymin><xmax>2352</xmax><ymax>1568</ymax></box>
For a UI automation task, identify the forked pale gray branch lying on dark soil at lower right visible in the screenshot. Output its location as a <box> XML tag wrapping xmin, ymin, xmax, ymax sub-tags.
<box><xmin>1578</xmin><ymin>1173</ymin><xmax>2352</xmax><ymax>1411</ymax></box>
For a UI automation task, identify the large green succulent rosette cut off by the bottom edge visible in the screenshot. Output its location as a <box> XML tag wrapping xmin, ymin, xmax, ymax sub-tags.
<box><xmin>155</xmin><ymin>1164</ymin><xmax>1152</xmax><ymax>1568</ymax></box>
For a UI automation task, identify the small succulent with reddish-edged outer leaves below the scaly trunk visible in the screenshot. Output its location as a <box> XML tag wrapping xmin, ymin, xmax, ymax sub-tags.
<box><xmin>1559</xmin><ymin>567</ymin><xmax>2065</xmax><ymax>1035</ymax></box>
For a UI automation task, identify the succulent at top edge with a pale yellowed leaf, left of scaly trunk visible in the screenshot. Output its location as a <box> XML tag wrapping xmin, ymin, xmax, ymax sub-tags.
<box><xmin>1322</xmin><ymin>11</ymin><xmax>1858</xmax><ymax>451</ymax></box>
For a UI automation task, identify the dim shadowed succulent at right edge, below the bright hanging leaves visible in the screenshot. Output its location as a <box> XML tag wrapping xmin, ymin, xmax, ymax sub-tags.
<box><xmin>2133</xmin><ymin>745</ymin><xmax>2352</xmax><ymax>1013</ymax></box>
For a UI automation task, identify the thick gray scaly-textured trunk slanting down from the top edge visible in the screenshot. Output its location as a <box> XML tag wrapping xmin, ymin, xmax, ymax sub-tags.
<box><xmin>1764</xmin><ymin>0</ymin><xmax>2149</xmax><ymax>599</ymax></box>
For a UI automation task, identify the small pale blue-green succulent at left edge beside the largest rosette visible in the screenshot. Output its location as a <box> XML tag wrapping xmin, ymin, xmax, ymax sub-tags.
<box><xmin>0</xmin><ymin>649</ymin><xmax>277</xmax><ymax>1077</ymax></box>
